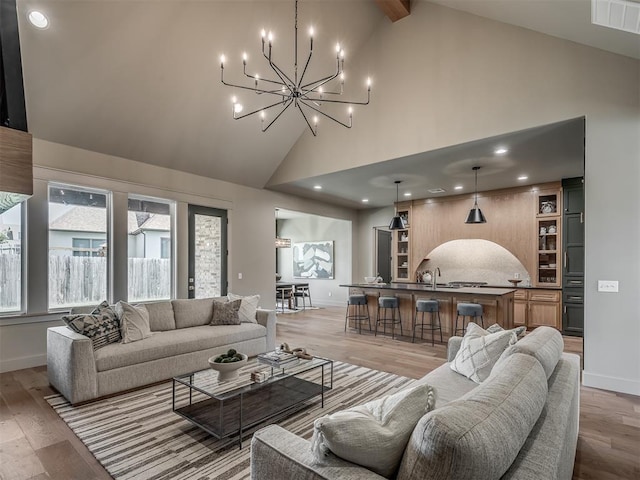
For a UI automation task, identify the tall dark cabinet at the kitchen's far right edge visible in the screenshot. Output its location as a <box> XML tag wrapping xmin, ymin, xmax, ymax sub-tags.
<box><xmin>562</xmin><ymin>177</ymin><xmax>584</xmax><ymax>336</ymax></box>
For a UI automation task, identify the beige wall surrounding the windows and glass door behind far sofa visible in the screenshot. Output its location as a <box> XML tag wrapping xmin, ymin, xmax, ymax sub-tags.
<box><xmin>0</xmin><ymin>139</ymin><xmax>357</xmax><ymax>371</ymax></box>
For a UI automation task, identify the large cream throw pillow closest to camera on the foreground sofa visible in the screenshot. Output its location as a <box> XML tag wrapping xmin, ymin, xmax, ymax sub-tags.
<box><xmin>311</xmin><ymin>384</ymin><xmax>436</xmax><ymax>477</ymax></box>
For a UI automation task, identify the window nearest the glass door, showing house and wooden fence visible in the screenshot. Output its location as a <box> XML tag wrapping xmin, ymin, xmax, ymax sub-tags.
<box><xmin>128</xmin><ymin>196</ymin><xmax>173</xmax><ymax>302</ymax></box>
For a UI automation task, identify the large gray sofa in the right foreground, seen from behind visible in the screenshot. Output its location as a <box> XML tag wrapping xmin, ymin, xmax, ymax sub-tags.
<box><xmin>251</xmin><ymin>327</ymin><xmax>580</xmax><ymax>480</ymax></box>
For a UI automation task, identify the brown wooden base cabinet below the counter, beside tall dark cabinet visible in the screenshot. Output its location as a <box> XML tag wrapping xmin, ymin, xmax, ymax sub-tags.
<box><xmin>513</xmin><ymin>289</ymin><xmax>562</xmax><ymax>330</ymax></box>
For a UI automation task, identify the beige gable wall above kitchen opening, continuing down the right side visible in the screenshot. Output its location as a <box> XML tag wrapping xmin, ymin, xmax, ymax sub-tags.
<box><xmin>270</xmin><ymin>2</ymin><xmax>640</xmax><ymax>395</ymax></box>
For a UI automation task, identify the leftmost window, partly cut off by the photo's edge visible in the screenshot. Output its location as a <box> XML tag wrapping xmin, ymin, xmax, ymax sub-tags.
<box><xmin>0</xmin><ymin>204</ymin><xmax>23</xmax><ymax>315</ymax></box>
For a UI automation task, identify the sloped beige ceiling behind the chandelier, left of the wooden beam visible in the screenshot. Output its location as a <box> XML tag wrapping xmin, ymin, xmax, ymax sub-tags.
<box><xmin>18</xmin><ymin>0</ymin><xmax>386</xmax><ymax>188</ymax></box>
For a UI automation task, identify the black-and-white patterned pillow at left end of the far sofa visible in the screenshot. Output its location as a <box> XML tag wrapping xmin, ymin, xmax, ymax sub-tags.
<box><xmin>62</xmin><ymin>301</ymin><xmax>122</xmax><ymax>350</ymax></box>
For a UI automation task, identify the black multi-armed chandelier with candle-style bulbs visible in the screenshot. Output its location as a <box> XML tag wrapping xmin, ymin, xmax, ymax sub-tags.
<box><xmin>220</xmin><ymin>0</ymin><xmax>371</xmax><ymax>136</ymax></box>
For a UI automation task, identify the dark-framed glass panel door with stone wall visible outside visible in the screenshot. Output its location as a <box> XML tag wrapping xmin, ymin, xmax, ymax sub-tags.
<box><xmin>189</xmin><ymin>205</ymin><xmax>227</xmax><ymax>298</ymax></box>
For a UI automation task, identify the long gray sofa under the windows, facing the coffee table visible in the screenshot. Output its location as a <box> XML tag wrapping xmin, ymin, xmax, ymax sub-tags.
<box><xmin>47</xmin><ymin>298</ymin><xmax>276</xmax><ymax>404</ymax></box>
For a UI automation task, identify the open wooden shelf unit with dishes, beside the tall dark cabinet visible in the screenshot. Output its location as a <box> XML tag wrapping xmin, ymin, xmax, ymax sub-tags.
<box><xmin>534</xmin><ymin>188</ymin><xmax>562</xmax><ymax>287</ymax></box>
